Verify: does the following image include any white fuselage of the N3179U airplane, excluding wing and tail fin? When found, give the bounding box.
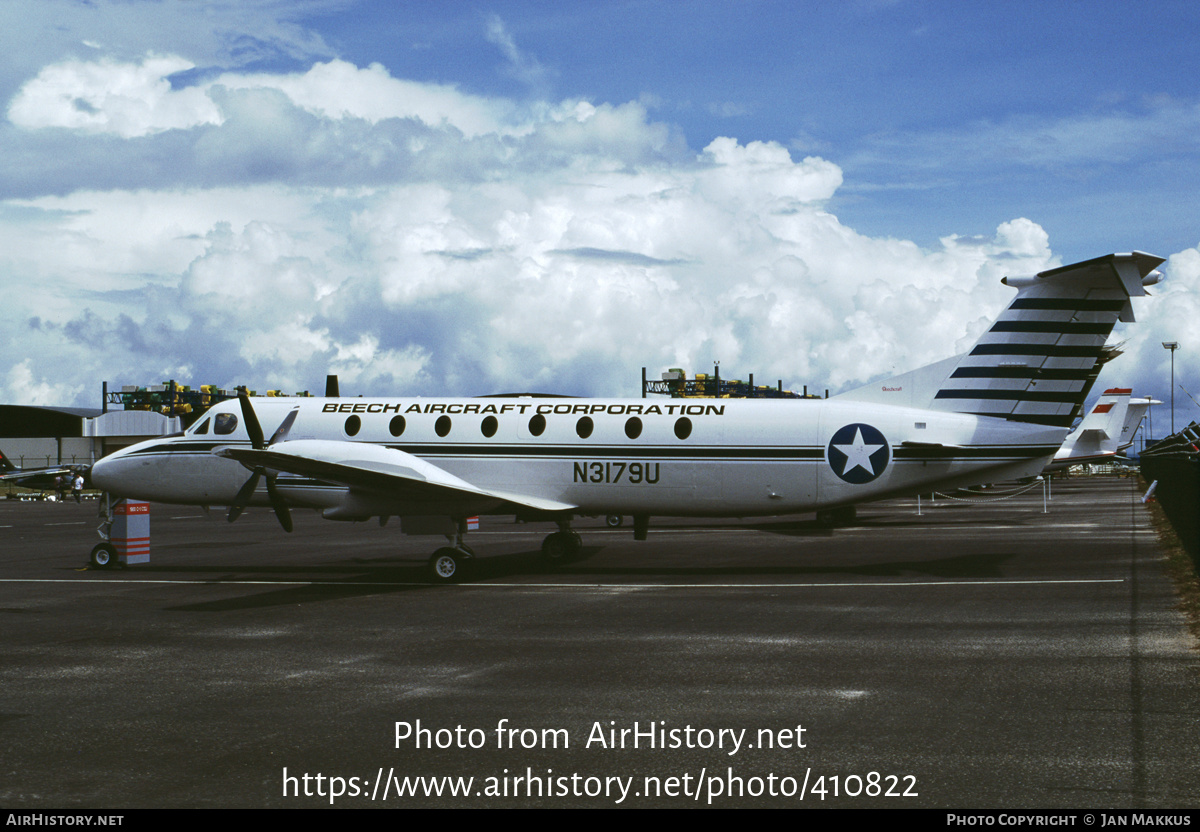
[92,397,1066,516]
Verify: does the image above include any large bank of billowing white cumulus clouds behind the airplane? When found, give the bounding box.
[0,51,1185,415]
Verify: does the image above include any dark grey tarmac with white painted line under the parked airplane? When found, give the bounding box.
[0,478,1200,810]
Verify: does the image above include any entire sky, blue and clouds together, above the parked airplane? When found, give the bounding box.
[0,0,1200,432]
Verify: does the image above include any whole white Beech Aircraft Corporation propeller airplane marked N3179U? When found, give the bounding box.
[91,252,1163,581]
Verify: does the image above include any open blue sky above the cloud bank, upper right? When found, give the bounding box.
[302,1,1200,261]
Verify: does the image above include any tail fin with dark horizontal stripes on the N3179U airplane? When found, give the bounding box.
[838,251,1163,427]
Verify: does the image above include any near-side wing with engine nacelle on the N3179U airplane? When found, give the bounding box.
[214,439,577,514]
